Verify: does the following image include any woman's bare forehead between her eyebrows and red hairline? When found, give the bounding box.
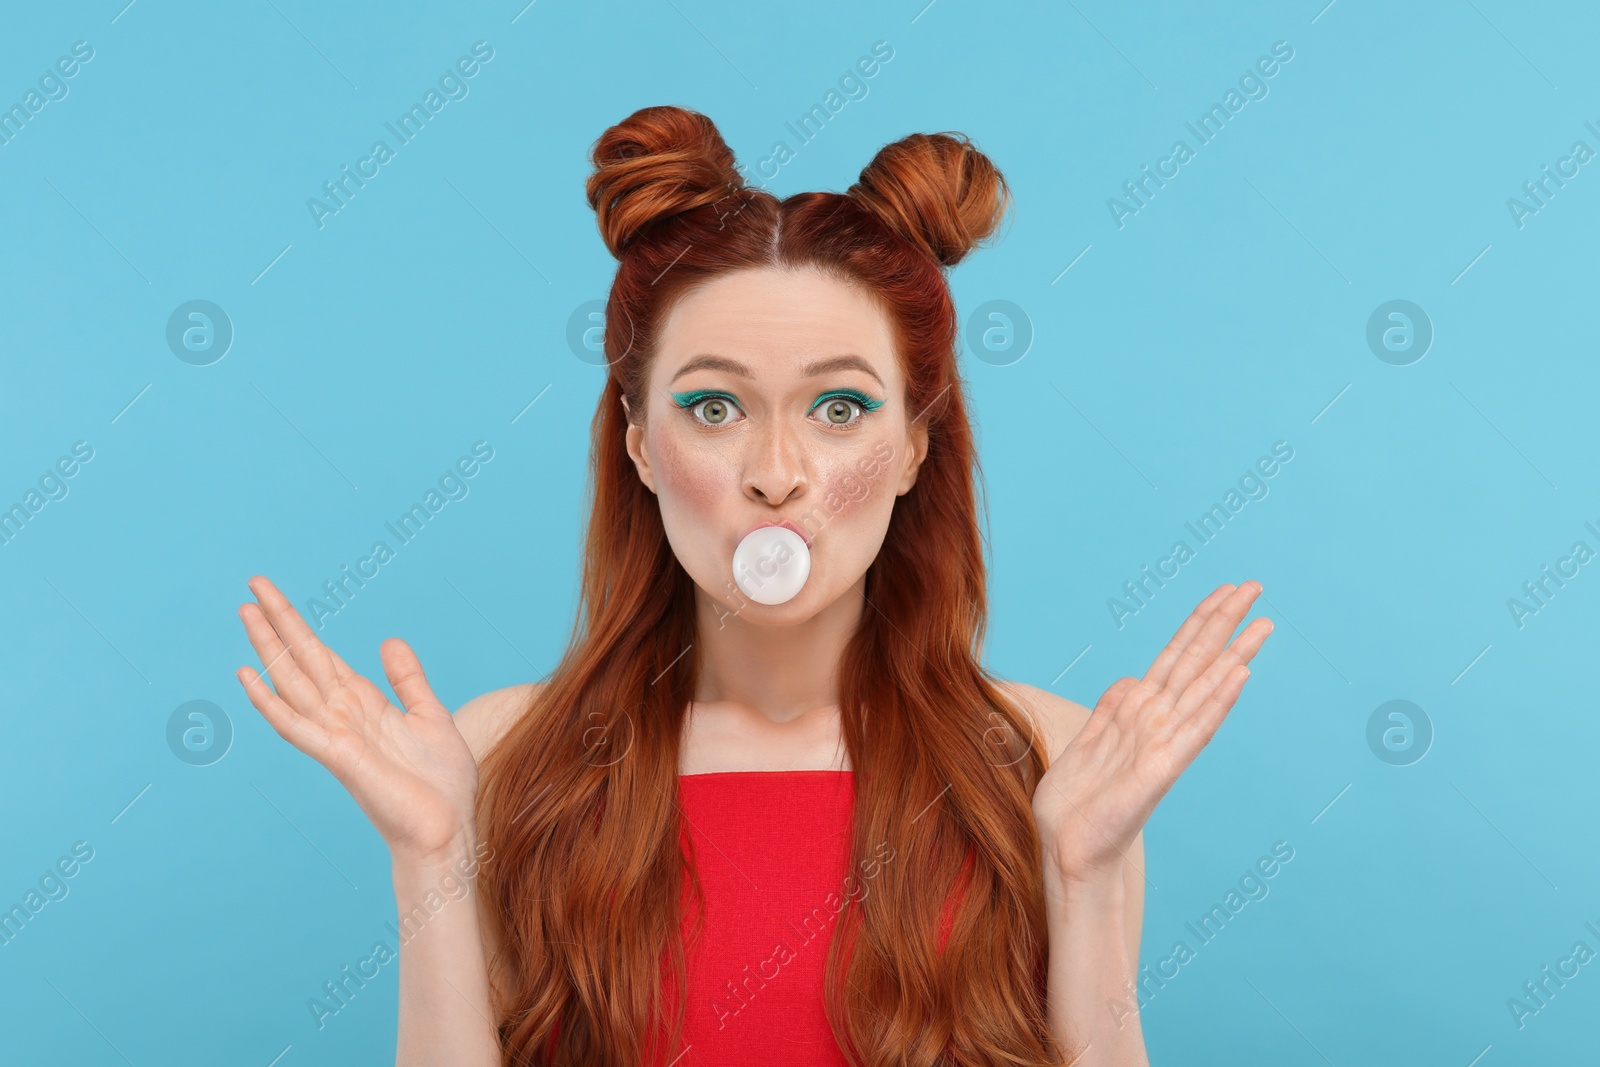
[656,267,898,381]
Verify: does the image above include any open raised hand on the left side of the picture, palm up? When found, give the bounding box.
[235,576,478,864]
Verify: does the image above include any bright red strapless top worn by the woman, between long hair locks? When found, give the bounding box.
[672,771,952,1067]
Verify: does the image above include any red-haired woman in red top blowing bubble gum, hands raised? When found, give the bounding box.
[238,107,1272,1067]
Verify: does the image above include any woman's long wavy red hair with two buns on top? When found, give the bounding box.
[478,107,1061,1067]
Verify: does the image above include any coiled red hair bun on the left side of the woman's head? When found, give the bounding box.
[584,106,744,259]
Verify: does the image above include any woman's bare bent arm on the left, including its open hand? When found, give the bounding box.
[238,576,528,1067]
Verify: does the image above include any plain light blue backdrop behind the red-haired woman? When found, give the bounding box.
[0,0,1600,1067]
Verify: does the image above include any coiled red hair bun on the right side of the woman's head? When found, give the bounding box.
[846,133,1011,267]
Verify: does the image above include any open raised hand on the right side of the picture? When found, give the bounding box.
[1034,581,1272,881]
